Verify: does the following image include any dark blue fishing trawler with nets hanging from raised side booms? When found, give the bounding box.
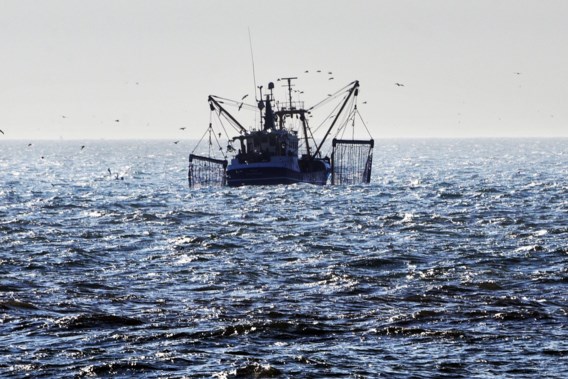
[188,77,374,188]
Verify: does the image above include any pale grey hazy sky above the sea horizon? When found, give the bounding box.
[0,0,568,139]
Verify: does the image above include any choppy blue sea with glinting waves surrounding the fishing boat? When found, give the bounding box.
[0,139,568,378]
